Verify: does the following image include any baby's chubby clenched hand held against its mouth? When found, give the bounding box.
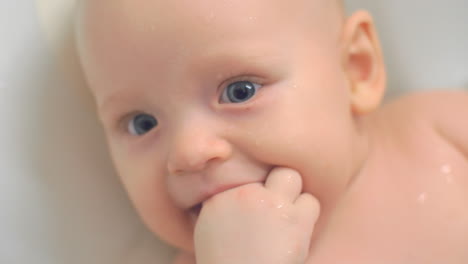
[195,168,319,264]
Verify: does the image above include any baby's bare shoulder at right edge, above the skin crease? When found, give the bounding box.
[381,90,468,159]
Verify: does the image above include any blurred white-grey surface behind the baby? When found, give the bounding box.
[0,0,468,264]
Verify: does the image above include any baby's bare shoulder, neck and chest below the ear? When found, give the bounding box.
[175,91,468,264]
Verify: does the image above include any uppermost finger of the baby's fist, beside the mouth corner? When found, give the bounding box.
[265,167,302,202]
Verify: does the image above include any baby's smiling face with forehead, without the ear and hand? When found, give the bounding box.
[78,0,366,250]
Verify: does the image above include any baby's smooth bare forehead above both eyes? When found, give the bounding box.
[77,0,340,100]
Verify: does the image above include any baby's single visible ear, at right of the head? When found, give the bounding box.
[342,11,386,115]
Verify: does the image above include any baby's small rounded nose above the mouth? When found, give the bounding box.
[167,124,232,175]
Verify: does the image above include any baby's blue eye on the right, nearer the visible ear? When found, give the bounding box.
[220,81,260,103]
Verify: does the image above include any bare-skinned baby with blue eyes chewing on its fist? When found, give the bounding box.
[73,0,468,264]
